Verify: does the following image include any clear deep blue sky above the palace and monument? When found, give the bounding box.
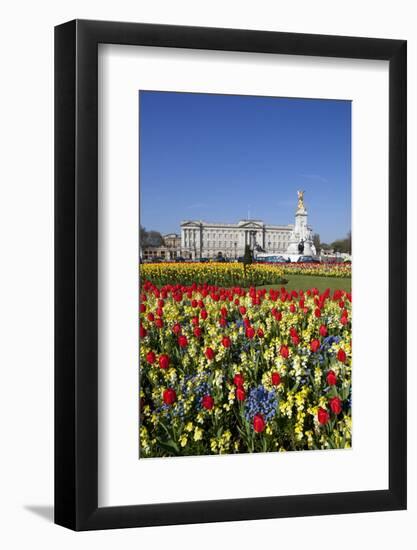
[139,91,351,242]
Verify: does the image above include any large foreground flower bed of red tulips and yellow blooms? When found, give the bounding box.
[140,280,351,457]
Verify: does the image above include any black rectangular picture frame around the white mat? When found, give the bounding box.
[55,20,407,531]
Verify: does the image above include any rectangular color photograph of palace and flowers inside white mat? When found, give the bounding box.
[139,91,352,458]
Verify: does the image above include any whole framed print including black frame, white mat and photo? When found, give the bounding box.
[55,21,406,530]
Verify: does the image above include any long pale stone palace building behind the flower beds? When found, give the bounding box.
[181,220,294,258]
